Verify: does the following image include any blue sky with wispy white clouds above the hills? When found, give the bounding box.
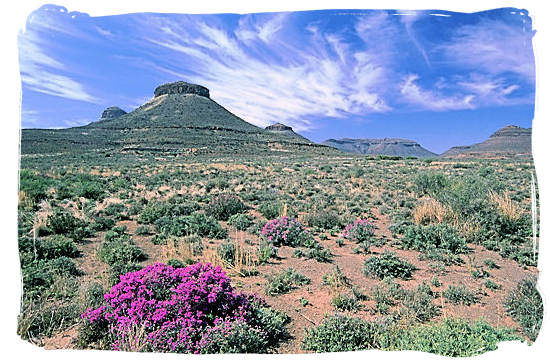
[19,5,535,153]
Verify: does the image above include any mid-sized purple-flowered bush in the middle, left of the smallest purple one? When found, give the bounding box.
[262,216,317,247]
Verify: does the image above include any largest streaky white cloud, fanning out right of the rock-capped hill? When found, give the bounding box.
[142,15,390,131]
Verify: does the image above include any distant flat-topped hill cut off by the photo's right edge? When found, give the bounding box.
[441,125,531,157]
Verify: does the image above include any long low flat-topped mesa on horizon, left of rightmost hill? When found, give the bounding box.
[321,138,437,158]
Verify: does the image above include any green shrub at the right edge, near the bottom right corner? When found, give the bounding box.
[504,276,544,341]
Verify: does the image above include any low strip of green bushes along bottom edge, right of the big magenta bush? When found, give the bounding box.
[302,315,518,357]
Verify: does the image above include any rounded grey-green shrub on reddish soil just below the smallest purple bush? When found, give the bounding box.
[363,252,416,279]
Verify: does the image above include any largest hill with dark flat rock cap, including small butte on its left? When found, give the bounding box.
[21,81,339,155]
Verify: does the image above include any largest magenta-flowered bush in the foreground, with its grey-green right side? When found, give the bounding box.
[81,263,288,353]
